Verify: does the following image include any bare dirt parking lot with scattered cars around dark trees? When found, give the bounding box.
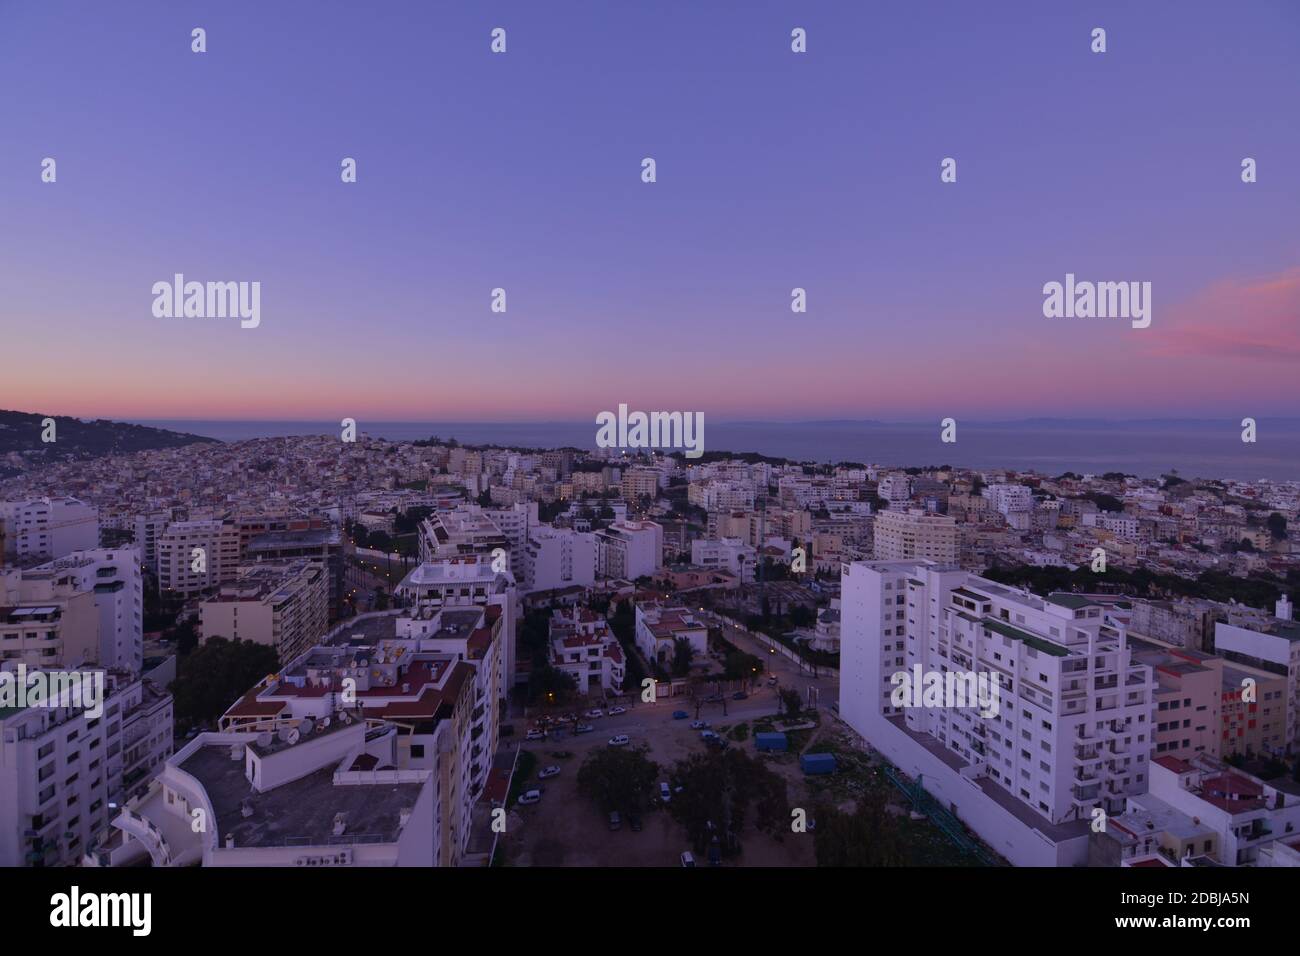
[502,688,815,866]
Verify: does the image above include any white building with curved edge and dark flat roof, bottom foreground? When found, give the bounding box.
[83,714,446,868]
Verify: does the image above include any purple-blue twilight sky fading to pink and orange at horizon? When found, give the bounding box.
[0,0,1300,420]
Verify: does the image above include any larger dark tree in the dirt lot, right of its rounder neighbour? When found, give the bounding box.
[668,748,790,856]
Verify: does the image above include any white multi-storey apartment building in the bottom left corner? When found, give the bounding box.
[0,671,173,866]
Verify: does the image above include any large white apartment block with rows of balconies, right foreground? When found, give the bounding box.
[840,562,1156,866]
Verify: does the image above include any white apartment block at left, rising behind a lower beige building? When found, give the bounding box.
[27,546,144,674]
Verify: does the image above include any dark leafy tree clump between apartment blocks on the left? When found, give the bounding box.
[172,637,280,727]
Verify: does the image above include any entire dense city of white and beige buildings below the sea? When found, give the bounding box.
[0,423,1300,868]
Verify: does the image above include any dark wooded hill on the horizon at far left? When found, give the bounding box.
[0,410,217,467]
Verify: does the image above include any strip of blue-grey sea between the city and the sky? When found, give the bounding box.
[131,418,1300,481]
